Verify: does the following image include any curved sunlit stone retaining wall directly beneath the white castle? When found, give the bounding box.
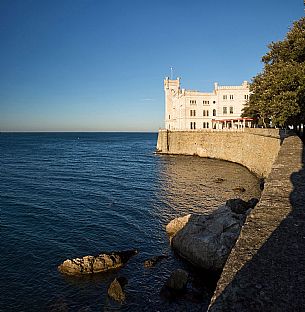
[157,129,281,177]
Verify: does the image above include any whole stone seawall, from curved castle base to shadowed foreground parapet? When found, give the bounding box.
[157,129,305,312]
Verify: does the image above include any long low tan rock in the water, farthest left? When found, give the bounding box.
[58,249,138,275]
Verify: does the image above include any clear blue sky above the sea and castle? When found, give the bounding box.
[0,0,304,131]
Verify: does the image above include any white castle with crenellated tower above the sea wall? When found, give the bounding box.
[164,77,252,130]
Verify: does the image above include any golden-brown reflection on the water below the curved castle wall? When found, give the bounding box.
[156,155,260,221]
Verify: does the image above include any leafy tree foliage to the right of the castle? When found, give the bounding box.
[243,17,305,126]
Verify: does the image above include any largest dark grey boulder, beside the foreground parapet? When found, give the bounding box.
[166,199,253,271]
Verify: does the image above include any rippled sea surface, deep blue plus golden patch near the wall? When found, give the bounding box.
[0,133,259,311]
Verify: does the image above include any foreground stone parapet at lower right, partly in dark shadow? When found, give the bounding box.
[209,137,305,312]
